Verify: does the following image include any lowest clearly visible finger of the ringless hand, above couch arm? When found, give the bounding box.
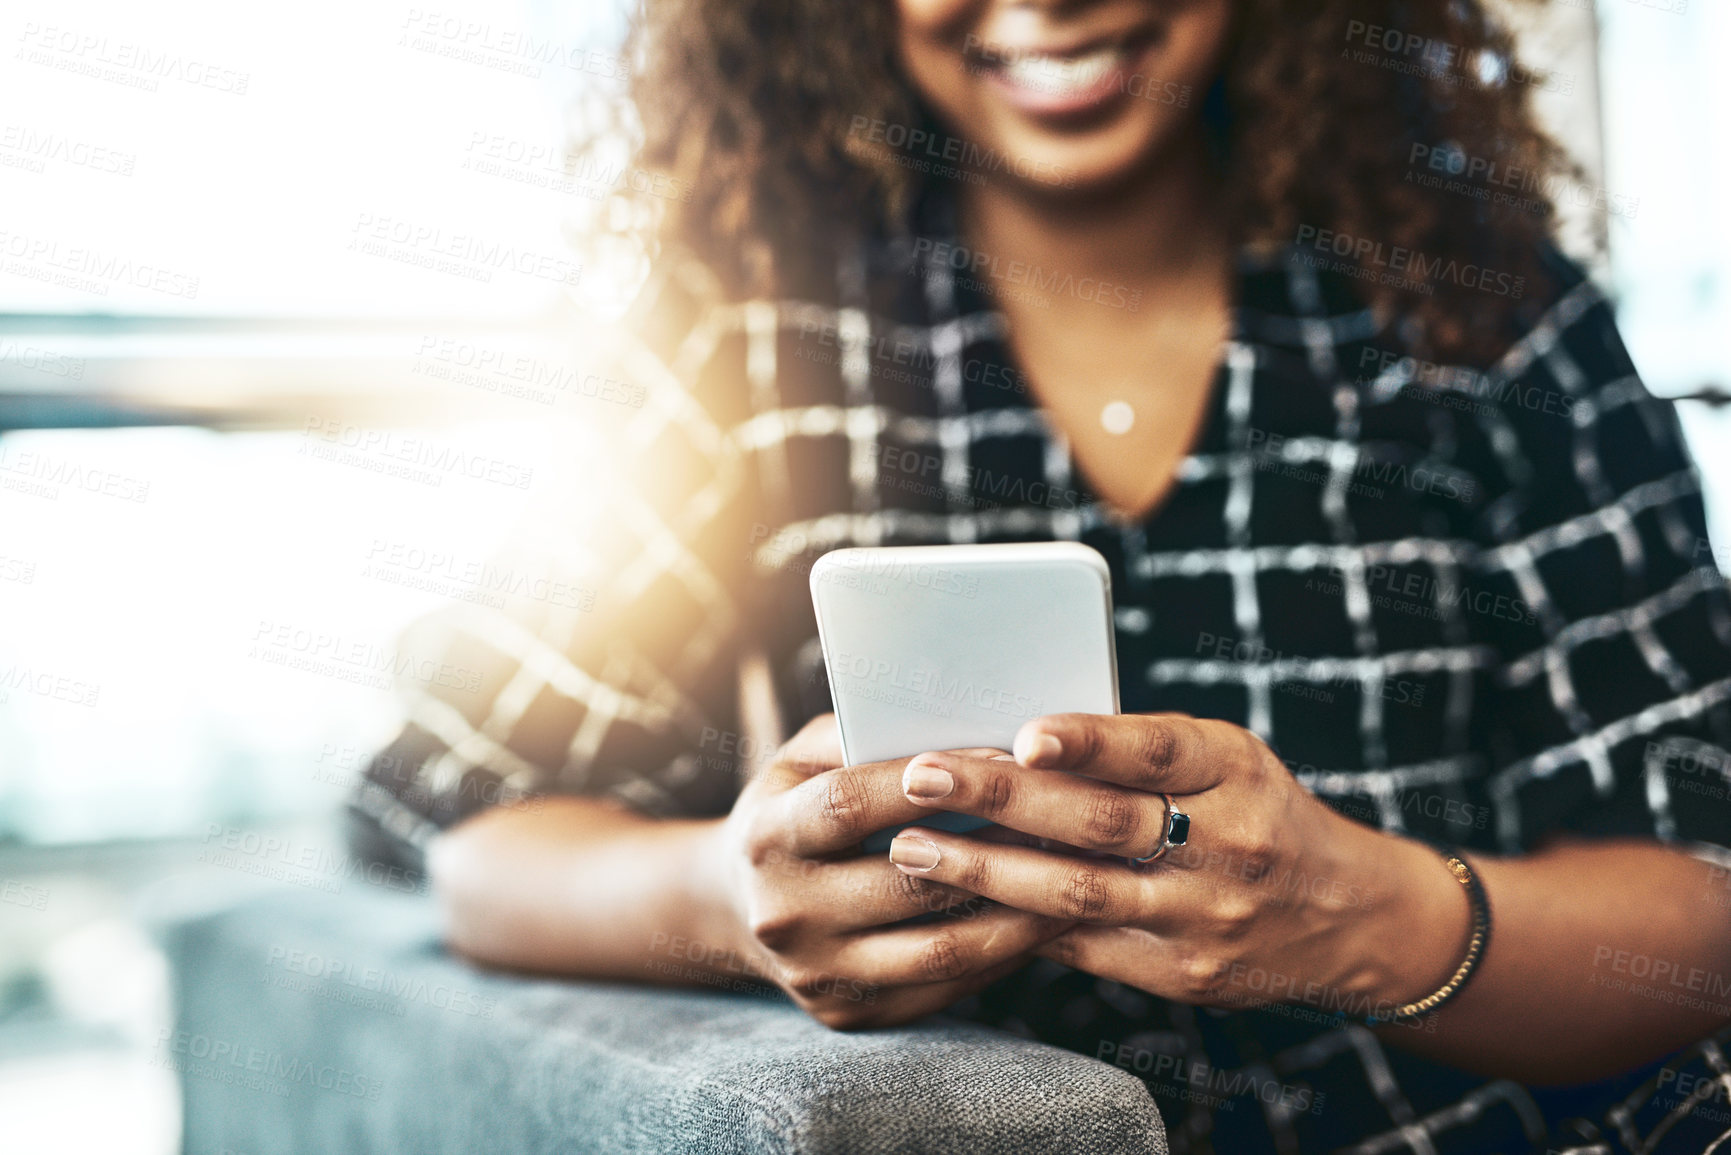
[833,906,1070,987]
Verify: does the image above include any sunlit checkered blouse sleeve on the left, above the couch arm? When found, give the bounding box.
[350,263,750,868]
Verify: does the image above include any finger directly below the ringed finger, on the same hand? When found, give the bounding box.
[890,826,1203,926]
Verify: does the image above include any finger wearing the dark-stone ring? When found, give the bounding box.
[902,753,1167,857]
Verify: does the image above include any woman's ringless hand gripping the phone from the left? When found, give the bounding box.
[703,713,1071,1030]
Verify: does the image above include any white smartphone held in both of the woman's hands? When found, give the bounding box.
[810,542,1118,849]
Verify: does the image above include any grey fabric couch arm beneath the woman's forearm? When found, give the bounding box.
[158,887,1167,1155]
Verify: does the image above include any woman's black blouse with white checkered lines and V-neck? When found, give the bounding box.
[353,193,1731,1155]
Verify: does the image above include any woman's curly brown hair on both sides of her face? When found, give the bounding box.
[615,0,1577,364]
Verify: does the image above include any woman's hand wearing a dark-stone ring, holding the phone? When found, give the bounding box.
[890,713,1470,1015]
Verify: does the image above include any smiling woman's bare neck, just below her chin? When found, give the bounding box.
[959,132,1226,293]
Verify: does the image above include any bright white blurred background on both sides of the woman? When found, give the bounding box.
[0,0,1731,1155]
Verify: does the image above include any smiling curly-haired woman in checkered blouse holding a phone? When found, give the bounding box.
[347,0,1731,1152]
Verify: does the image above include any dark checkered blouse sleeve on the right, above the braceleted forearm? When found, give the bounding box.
[1471,259,1731,864]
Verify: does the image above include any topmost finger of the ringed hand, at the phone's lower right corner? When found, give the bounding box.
[1016,713,1267,795]
